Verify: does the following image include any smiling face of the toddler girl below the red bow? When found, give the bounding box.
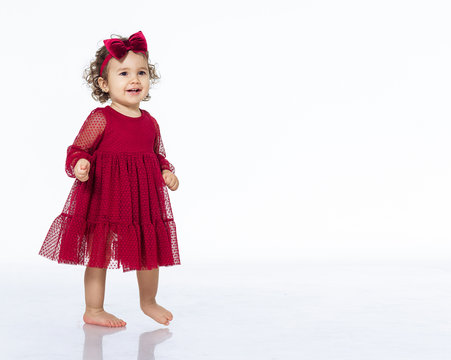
[98,51,150,109]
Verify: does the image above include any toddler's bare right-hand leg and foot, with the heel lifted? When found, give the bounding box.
[136,268,173,325]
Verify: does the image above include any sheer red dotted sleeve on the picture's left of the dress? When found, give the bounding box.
[66,108,106,178]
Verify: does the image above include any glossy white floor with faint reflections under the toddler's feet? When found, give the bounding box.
[0,258,451,360]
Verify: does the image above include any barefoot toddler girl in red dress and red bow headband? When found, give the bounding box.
[39,31,180,327]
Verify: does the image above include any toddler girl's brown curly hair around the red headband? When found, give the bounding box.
[83,34,160,103]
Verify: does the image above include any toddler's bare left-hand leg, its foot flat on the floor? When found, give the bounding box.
[83,266,126,327]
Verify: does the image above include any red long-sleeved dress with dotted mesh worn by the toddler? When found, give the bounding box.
[39,106,180,272]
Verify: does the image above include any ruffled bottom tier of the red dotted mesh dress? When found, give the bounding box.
[39,212,180,272]
